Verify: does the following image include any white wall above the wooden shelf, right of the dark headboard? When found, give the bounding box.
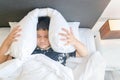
[92,0,120,34]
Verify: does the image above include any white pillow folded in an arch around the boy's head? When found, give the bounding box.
[8,8,79,58]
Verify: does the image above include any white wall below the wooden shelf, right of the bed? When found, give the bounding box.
[95,32,120,67]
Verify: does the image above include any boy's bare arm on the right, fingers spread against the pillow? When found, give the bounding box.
[60,28,88,57]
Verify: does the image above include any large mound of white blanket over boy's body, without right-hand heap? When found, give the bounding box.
[0,54,74,80]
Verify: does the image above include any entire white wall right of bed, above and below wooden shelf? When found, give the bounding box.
[92,0,120,67]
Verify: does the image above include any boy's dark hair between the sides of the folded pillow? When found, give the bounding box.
[37,16,50,30]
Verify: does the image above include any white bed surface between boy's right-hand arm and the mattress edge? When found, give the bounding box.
[79,28,96,54]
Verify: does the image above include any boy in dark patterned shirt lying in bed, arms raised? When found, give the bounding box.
[0,17,88,65]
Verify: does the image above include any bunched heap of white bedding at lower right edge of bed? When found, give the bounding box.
[67,52,105,80]
